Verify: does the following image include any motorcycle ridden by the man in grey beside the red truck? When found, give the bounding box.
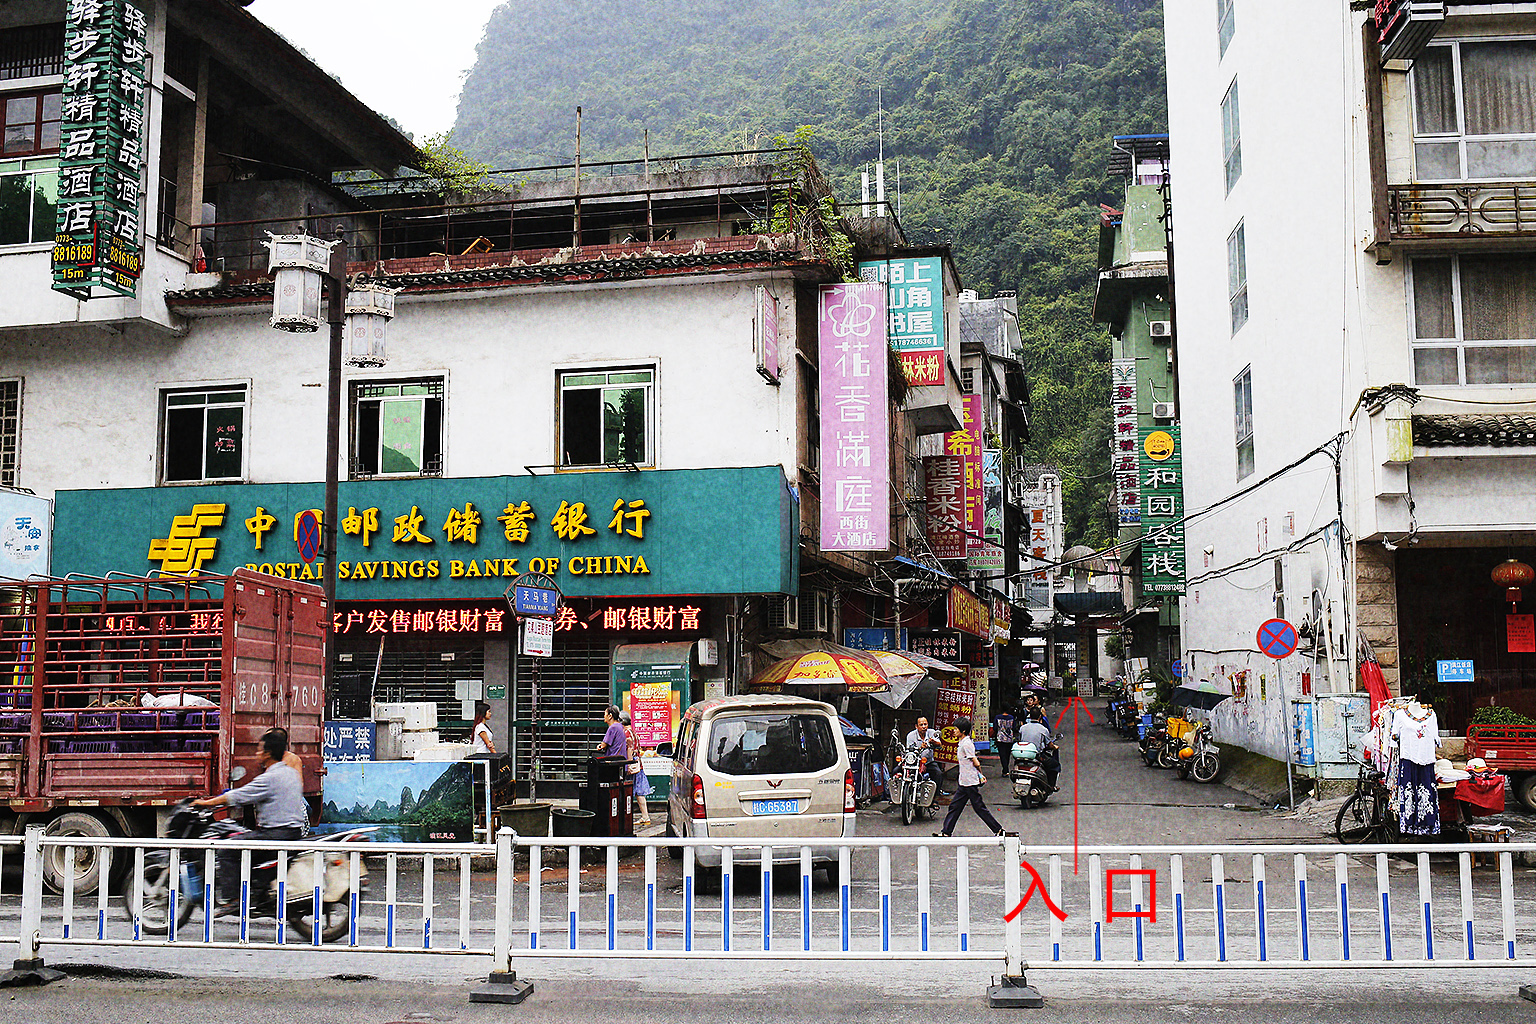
[123,801,378,943]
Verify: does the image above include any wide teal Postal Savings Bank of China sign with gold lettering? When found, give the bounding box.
[54,467,804,600]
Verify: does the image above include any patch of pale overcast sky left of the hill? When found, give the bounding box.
[249,0,502,143]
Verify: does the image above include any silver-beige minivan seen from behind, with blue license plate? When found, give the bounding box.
[667,694,854,867]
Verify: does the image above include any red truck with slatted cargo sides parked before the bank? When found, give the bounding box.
[0,570,329,892]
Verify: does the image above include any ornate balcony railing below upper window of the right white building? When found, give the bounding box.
[1387,181,1536,244]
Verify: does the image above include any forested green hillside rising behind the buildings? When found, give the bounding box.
[453,0,1161,545]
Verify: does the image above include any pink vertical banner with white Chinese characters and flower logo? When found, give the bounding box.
[817,281,891,551]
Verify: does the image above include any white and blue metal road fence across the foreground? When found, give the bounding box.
[0,829,1536,973]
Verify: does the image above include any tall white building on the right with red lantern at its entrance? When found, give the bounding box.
[1164,0,1536,757]
